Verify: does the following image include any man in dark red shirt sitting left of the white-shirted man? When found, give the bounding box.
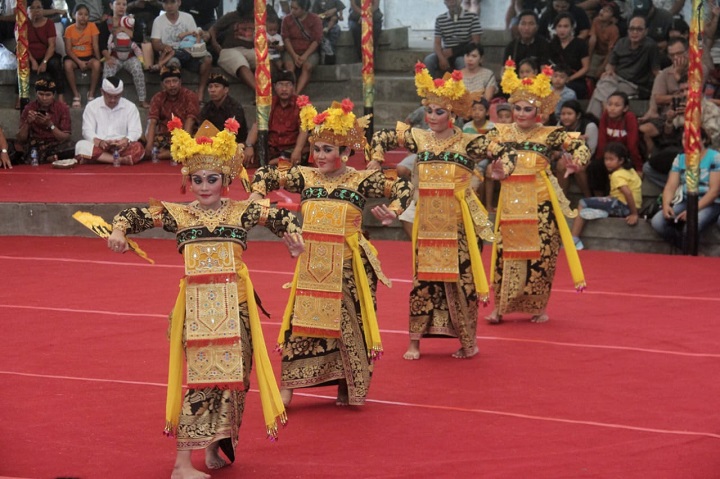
[15,75,72,164]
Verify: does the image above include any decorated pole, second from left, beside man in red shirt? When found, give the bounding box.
[255,0,272,166]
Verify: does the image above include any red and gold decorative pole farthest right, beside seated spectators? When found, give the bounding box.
[683,0,704,256]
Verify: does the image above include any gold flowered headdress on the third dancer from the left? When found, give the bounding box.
[415,62,472,118]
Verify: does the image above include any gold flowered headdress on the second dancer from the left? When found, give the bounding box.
[297,95,370,156]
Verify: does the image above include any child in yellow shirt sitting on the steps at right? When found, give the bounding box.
[572,142,642,250]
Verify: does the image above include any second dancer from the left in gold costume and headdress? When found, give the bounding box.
[251,96,412,406]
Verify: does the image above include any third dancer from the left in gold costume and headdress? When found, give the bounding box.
[368,63,514,360]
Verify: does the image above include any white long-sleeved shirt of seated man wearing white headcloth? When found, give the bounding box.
[82,95,142,141]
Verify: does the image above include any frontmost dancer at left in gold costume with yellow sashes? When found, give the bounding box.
[108,118,303,479]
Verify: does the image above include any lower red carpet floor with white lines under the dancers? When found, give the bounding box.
[0,238,720,479]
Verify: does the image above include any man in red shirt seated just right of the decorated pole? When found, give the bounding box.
[245,69,309,167]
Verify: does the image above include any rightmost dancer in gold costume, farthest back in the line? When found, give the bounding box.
[485,60,590,323]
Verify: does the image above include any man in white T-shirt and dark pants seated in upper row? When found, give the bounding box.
[150,0,212,101]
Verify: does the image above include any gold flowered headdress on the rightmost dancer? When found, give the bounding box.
[500,58,560,115]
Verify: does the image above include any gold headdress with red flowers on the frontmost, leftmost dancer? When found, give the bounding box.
[167,115,247,191]
